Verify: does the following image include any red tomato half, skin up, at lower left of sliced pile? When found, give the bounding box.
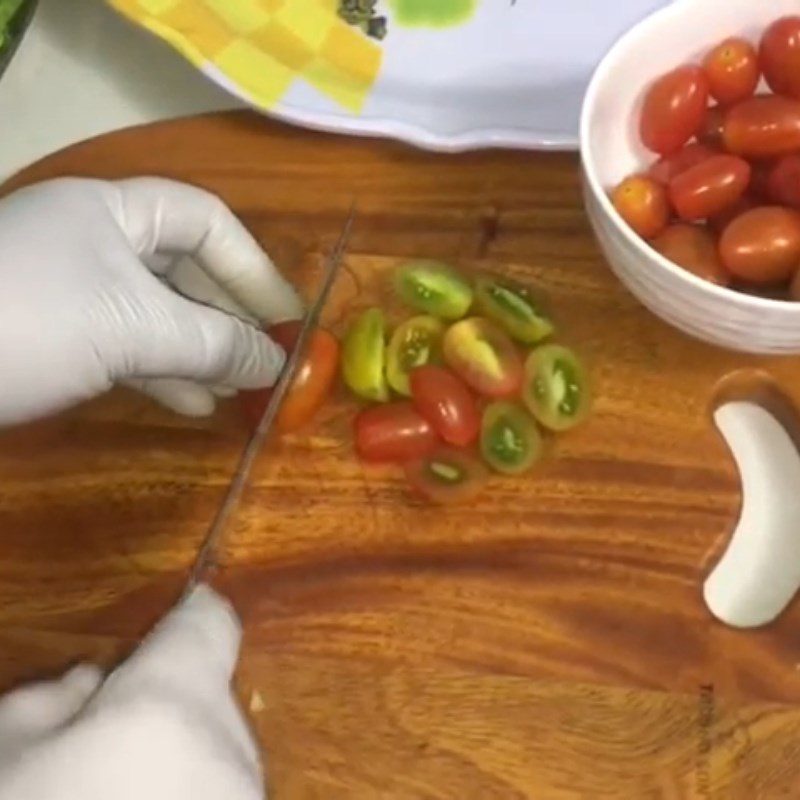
[353,400,437,463]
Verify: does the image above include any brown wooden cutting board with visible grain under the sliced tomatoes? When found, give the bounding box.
[0,114,800,800]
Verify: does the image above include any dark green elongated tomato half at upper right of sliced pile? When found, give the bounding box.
[475,275,553,344]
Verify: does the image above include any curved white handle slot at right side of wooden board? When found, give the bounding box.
[703,402,800,628]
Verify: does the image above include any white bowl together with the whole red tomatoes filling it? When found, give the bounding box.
[581,0,800,354]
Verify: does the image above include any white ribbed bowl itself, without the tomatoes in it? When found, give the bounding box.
[580,0,800,353]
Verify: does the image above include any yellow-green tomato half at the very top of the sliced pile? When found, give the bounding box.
[395,260,472,320]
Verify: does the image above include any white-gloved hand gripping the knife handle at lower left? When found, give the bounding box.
[0,587,264,800]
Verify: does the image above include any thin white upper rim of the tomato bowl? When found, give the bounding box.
[579,0,800,316]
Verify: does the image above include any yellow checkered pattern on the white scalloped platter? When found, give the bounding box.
[109,0,383,113]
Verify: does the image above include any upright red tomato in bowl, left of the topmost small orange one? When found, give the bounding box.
[639,65,709,155]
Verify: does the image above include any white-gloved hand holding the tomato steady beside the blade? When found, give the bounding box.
[0,178,302,425]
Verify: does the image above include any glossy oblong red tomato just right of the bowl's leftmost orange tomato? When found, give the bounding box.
[669,155,750,222]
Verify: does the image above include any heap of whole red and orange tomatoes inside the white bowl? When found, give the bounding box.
[611,16,800,300]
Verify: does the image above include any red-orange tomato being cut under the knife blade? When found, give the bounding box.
[239,321,339,433]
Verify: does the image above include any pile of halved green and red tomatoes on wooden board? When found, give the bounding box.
[342,261,590,503]
